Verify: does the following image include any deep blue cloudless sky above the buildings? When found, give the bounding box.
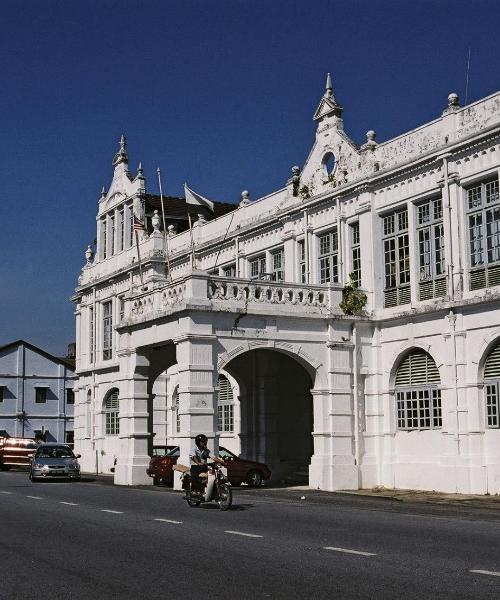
[0,0,500,354]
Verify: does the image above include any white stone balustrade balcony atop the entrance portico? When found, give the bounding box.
[118,271,348,328]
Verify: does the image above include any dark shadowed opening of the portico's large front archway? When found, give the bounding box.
[224,348,314,483]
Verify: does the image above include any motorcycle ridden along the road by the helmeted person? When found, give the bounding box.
[172,463,233,510]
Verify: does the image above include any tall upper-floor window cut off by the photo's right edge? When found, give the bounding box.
[466,177,500,290]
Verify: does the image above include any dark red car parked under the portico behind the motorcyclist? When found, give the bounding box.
[146,446,271,487]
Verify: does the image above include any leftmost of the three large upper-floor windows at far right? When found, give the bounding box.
[382,209,411,308]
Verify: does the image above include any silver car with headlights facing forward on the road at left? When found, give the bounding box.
[29,444,80,481]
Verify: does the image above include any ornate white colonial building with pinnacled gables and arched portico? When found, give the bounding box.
[74,77,500,493]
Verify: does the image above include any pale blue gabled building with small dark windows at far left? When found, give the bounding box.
[0,340,76,444]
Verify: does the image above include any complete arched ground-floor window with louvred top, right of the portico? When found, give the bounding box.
[396,350,443,430]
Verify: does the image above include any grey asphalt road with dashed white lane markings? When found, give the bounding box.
[0,471,500,600]
